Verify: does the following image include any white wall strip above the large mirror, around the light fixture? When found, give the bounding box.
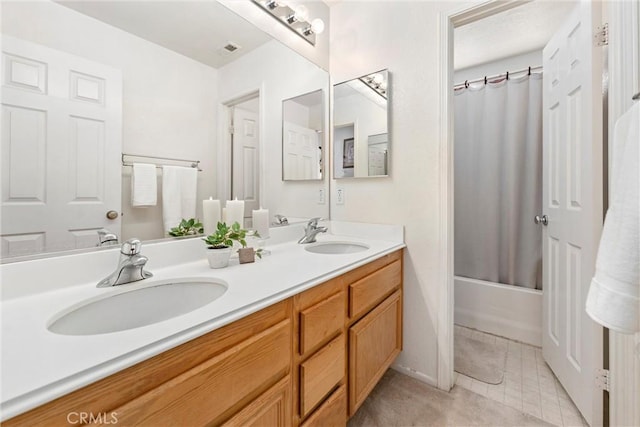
[218,0,331,70]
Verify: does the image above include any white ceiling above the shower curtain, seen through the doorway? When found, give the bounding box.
[454,0,577,70]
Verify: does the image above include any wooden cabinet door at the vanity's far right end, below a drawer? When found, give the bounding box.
[349,291,402,417]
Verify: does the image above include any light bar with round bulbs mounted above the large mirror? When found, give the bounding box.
[252,0,324,46]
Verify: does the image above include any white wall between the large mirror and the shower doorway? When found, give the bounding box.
[331,1,479,387]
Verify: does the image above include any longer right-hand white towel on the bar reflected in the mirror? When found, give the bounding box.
[162,166,198,233]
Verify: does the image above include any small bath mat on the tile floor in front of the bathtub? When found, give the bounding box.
[454,333,507,384]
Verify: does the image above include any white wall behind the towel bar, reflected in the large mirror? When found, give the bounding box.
[2,1,217,240]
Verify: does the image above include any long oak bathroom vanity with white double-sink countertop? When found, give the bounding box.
[2,222,404,426]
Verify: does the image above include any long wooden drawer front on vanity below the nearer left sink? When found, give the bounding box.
[114,320,291,426]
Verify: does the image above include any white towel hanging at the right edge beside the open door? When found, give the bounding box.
[586,103,640,333]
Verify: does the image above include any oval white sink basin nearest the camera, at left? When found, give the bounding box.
[48,279,227,335]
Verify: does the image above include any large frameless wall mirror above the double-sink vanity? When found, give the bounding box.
[0,0,329,262]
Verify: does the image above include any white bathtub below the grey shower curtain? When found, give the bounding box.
[454,276,542,347]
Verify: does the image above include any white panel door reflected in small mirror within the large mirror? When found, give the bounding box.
[283,122,320,180]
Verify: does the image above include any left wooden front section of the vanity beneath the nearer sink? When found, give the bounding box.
[2,299,292,427]
